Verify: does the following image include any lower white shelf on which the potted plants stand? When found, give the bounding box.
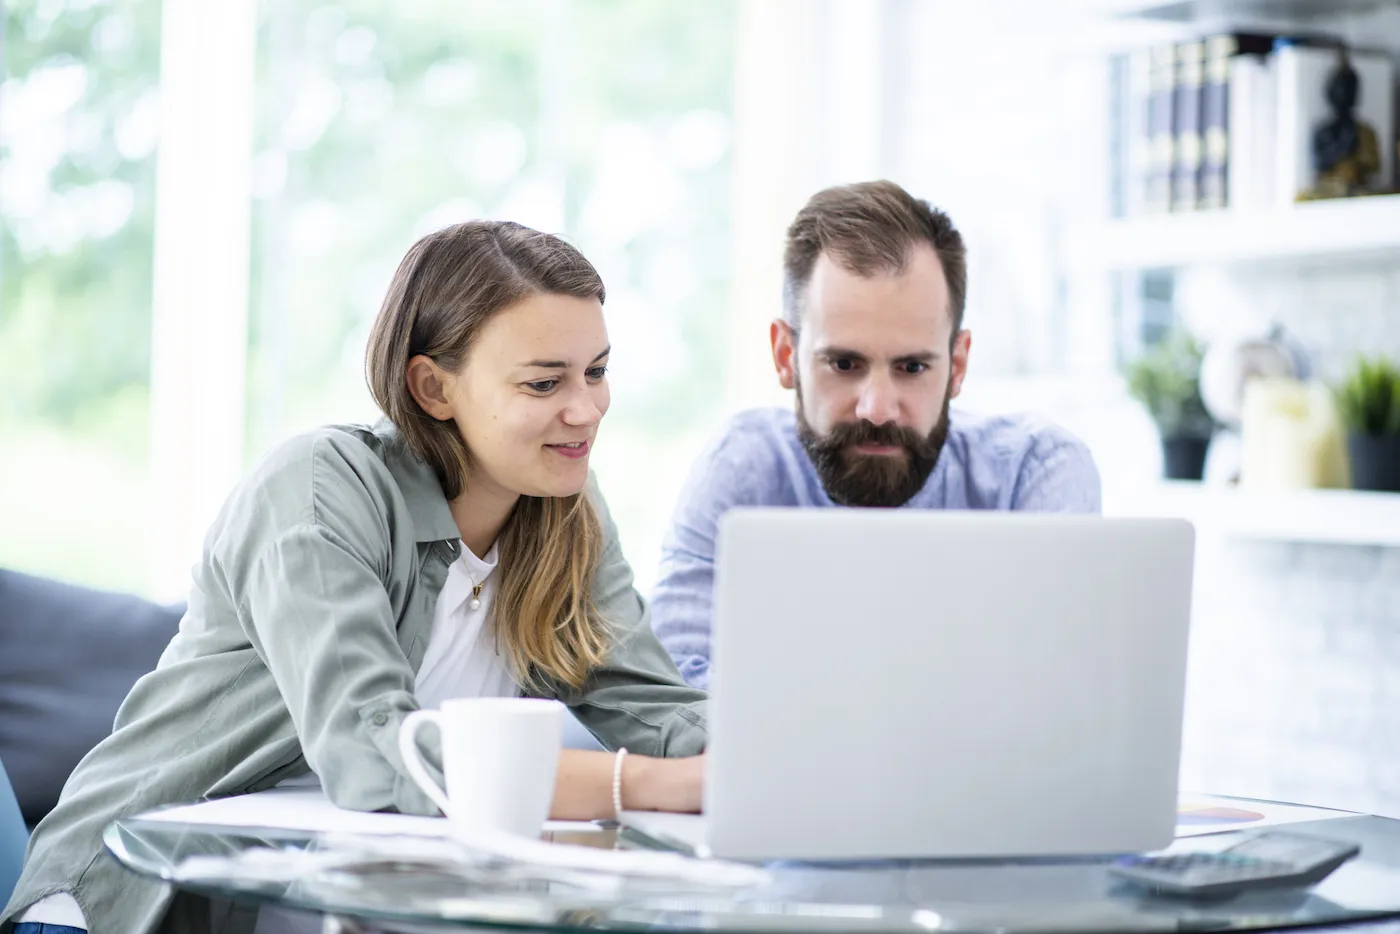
[1105,482,1400,546]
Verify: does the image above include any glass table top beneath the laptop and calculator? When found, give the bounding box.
[105,816,1400,934]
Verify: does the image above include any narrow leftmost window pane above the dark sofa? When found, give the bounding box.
[0,0,161,590]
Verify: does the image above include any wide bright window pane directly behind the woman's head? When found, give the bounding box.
[246,0,735,585]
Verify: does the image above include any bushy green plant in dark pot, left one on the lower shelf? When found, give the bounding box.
[1127,330,1215,480]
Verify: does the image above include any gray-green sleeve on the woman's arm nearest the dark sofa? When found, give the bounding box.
[216,440,441,814]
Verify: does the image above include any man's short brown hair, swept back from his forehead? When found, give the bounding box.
[783,181,967,335]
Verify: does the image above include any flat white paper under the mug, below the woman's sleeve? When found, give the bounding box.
[139,787,585,836]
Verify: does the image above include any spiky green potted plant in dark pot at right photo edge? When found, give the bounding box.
[1336,357,1400,493]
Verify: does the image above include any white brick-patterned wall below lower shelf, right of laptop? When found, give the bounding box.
[1183,541,1400,814]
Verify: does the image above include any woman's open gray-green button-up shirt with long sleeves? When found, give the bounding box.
[0,423,706,934]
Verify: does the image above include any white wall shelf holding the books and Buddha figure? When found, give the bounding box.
[1071,195,1400,270]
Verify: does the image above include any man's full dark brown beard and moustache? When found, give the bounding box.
[797,381,952,507]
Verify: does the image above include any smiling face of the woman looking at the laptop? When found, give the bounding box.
[422,294,609,496]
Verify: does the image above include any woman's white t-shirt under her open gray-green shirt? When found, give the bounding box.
[17,545,519,934]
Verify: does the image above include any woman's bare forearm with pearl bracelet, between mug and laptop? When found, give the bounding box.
[549,749,704,821]
